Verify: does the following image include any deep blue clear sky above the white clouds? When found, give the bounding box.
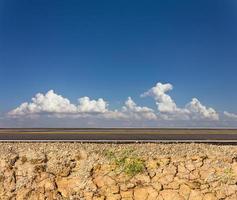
[0,0,237,126]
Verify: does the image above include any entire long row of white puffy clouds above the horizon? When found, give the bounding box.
[4,83,237,125]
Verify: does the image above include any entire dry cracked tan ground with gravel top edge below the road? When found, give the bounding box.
[0,143,237,200]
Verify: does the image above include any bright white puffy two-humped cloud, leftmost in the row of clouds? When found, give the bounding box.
[8,90,107,117]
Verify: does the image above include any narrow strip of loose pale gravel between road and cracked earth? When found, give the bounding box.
[0,142,237,157]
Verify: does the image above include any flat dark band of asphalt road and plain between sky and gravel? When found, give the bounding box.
[0,128,237,142]
